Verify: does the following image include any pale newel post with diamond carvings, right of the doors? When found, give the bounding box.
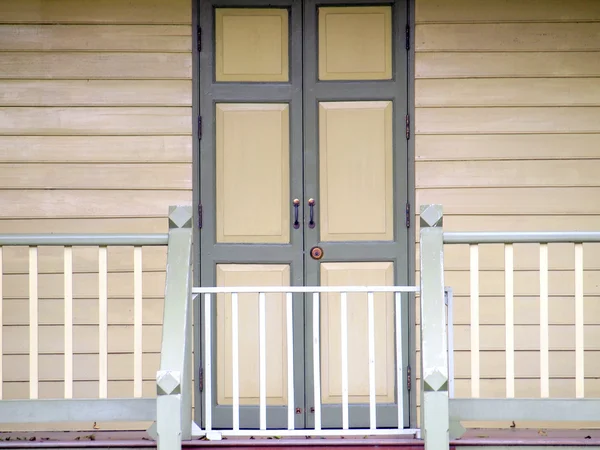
[420,205,450,450]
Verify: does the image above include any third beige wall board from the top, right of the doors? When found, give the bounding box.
[415,52,600,78]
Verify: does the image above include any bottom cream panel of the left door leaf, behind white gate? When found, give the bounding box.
[217,264,290,405]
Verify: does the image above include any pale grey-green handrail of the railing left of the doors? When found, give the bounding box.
[0,233,169,247]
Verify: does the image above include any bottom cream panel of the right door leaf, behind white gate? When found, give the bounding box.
[321,262,395,404]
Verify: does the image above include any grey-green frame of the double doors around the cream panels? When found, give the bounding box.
[191,0,416,429]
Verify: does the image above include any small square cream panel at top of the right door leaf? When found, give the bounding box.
[319,6,392,80]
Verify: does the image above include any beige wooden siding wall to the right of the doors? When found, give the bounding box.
[415,0,600,426]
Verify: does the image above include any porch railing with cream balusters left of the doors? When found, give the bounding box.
[0,234,168,424]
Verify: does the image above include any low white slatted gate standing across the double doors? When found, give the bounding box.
[192,286,419,439]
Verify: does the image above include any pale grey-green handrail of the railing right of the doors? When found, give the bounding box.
[444,231,600,244]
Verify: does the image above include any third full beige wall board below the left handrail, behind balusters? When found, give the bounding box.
[2,297,164,327]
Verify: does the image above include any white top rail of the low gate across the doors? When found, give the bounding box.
[192,286,419,294]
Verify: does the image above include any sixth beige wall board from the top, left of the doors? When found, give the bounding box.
[0,136,192,164]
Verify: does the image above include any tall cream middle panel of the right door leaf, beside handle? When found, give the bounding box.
[319,101,394,241]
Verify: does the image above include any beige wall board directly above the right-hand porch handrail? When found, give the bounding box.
[414,215,600,236]
